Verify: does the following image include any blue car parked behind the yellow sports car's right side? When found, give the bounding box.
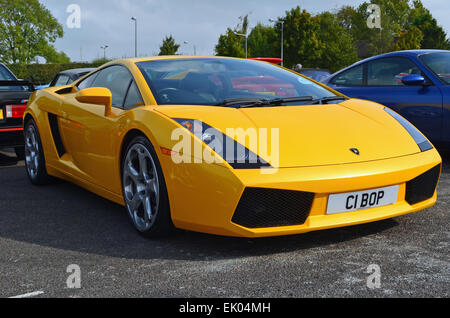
[323,50,450,148]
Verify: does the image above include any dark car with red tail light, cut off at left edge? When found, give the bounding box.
[0,63,34,159]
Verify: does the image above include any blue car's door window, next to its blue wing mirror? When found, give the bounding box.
[367,57,424,86]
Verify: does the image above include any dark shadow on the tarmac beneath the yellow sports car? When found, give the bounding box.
[0,167,404,261]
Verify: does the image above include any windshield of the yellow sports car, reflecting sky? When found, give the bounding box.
[137,58,336,105]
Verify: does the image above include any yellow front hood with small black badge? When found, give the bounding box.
[157,99,420,168]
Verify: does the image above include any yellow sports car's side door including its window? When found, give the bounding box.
[62,65,137,192]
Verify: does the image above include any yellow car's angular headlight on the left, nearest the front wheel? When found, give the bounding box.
[173,118,272,169]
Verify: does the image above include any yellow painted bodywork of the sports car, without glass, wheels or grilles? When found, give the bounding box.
[24,57,441,237]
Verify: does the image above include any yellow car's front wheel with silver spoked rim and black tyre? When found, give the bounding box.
[122,136,174,238]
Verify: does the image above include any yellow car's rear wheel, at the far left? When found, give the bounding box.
[24,119,52,185]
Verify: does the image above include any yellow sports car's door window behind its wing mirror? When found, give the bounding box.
[91,65,133,108]
